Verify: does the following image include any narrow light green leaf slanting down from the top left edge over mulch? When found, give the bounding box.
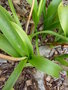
[8,0,21,27]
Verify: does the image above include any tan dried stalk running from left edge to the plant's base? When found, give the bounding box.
[0,54,27,61]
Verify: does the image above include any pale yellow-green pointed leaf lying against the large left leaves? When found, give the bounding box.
[11,22,33,56]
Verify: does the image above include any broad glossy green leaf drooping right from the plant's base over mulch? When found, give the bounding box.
[29,56,62,77]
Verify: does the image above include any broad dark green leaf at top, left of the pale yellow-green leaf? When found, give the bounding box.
[43,0,62,30]
